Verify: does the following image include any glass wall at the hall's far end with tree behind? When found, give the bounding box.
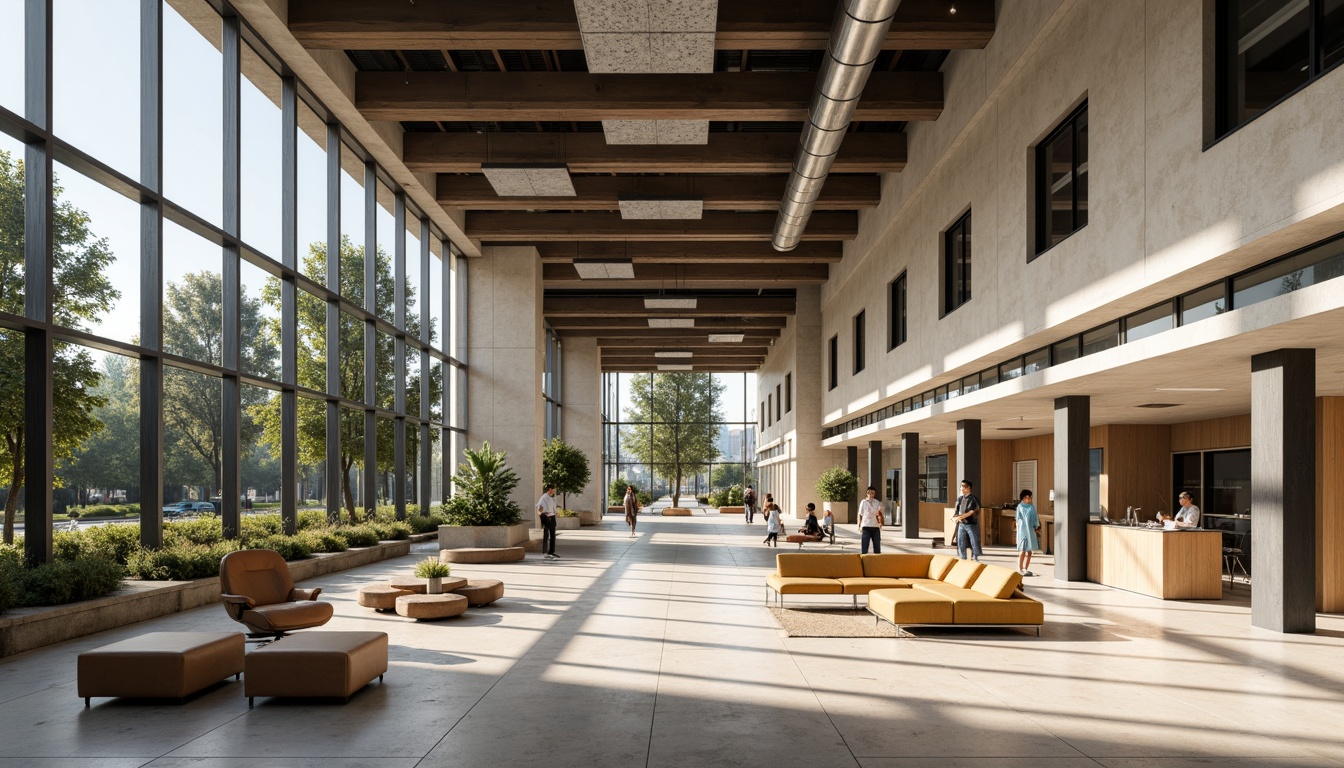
[602,373,757,504]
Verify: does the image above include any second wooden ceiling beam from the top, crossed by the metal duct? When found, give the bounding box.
[355,71,943,121]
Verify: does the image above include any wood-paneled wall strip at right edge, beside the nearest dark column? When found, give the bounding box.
[1316,397,1344,613]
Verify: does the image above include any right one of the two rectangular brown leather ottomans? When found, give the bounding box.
[243,632,387,709]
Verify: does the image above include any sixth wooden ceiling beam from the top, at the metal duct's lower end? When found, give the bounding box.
[532,241,844,264]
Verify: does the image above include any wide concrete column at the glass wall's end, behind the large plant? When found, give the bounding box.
[466,246,546,525]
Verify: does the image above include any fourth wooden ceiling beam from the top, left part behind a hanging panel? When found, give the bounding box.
[437,174,882,211]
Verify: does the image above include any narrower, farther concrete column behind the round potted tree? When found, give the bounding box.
[560,336,606,512]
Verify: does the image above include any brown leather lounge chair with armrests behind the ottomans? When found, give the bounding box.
[219,549,335,638]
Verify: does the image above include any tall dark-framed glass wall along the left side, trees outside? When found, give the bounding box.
[0,0,466,560]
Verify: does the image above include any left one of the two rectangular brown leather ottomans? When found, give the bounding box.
[78,632,243,706]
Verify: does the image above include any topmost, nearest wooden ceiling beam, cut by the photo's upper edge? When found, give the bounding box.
[289,0,995,51]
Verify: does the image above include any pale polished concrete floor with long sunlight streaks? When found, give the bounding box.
[0,515,1344,768]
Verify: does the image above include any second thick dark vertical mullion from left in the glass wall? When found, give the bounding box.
[140,0,164,547]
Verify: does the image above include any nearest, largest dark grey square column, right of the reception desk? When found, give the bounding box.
[1251,350,1316,633]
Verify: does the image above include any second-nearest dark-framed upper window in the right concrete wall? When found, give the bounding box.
[1036,101,1087,256]
